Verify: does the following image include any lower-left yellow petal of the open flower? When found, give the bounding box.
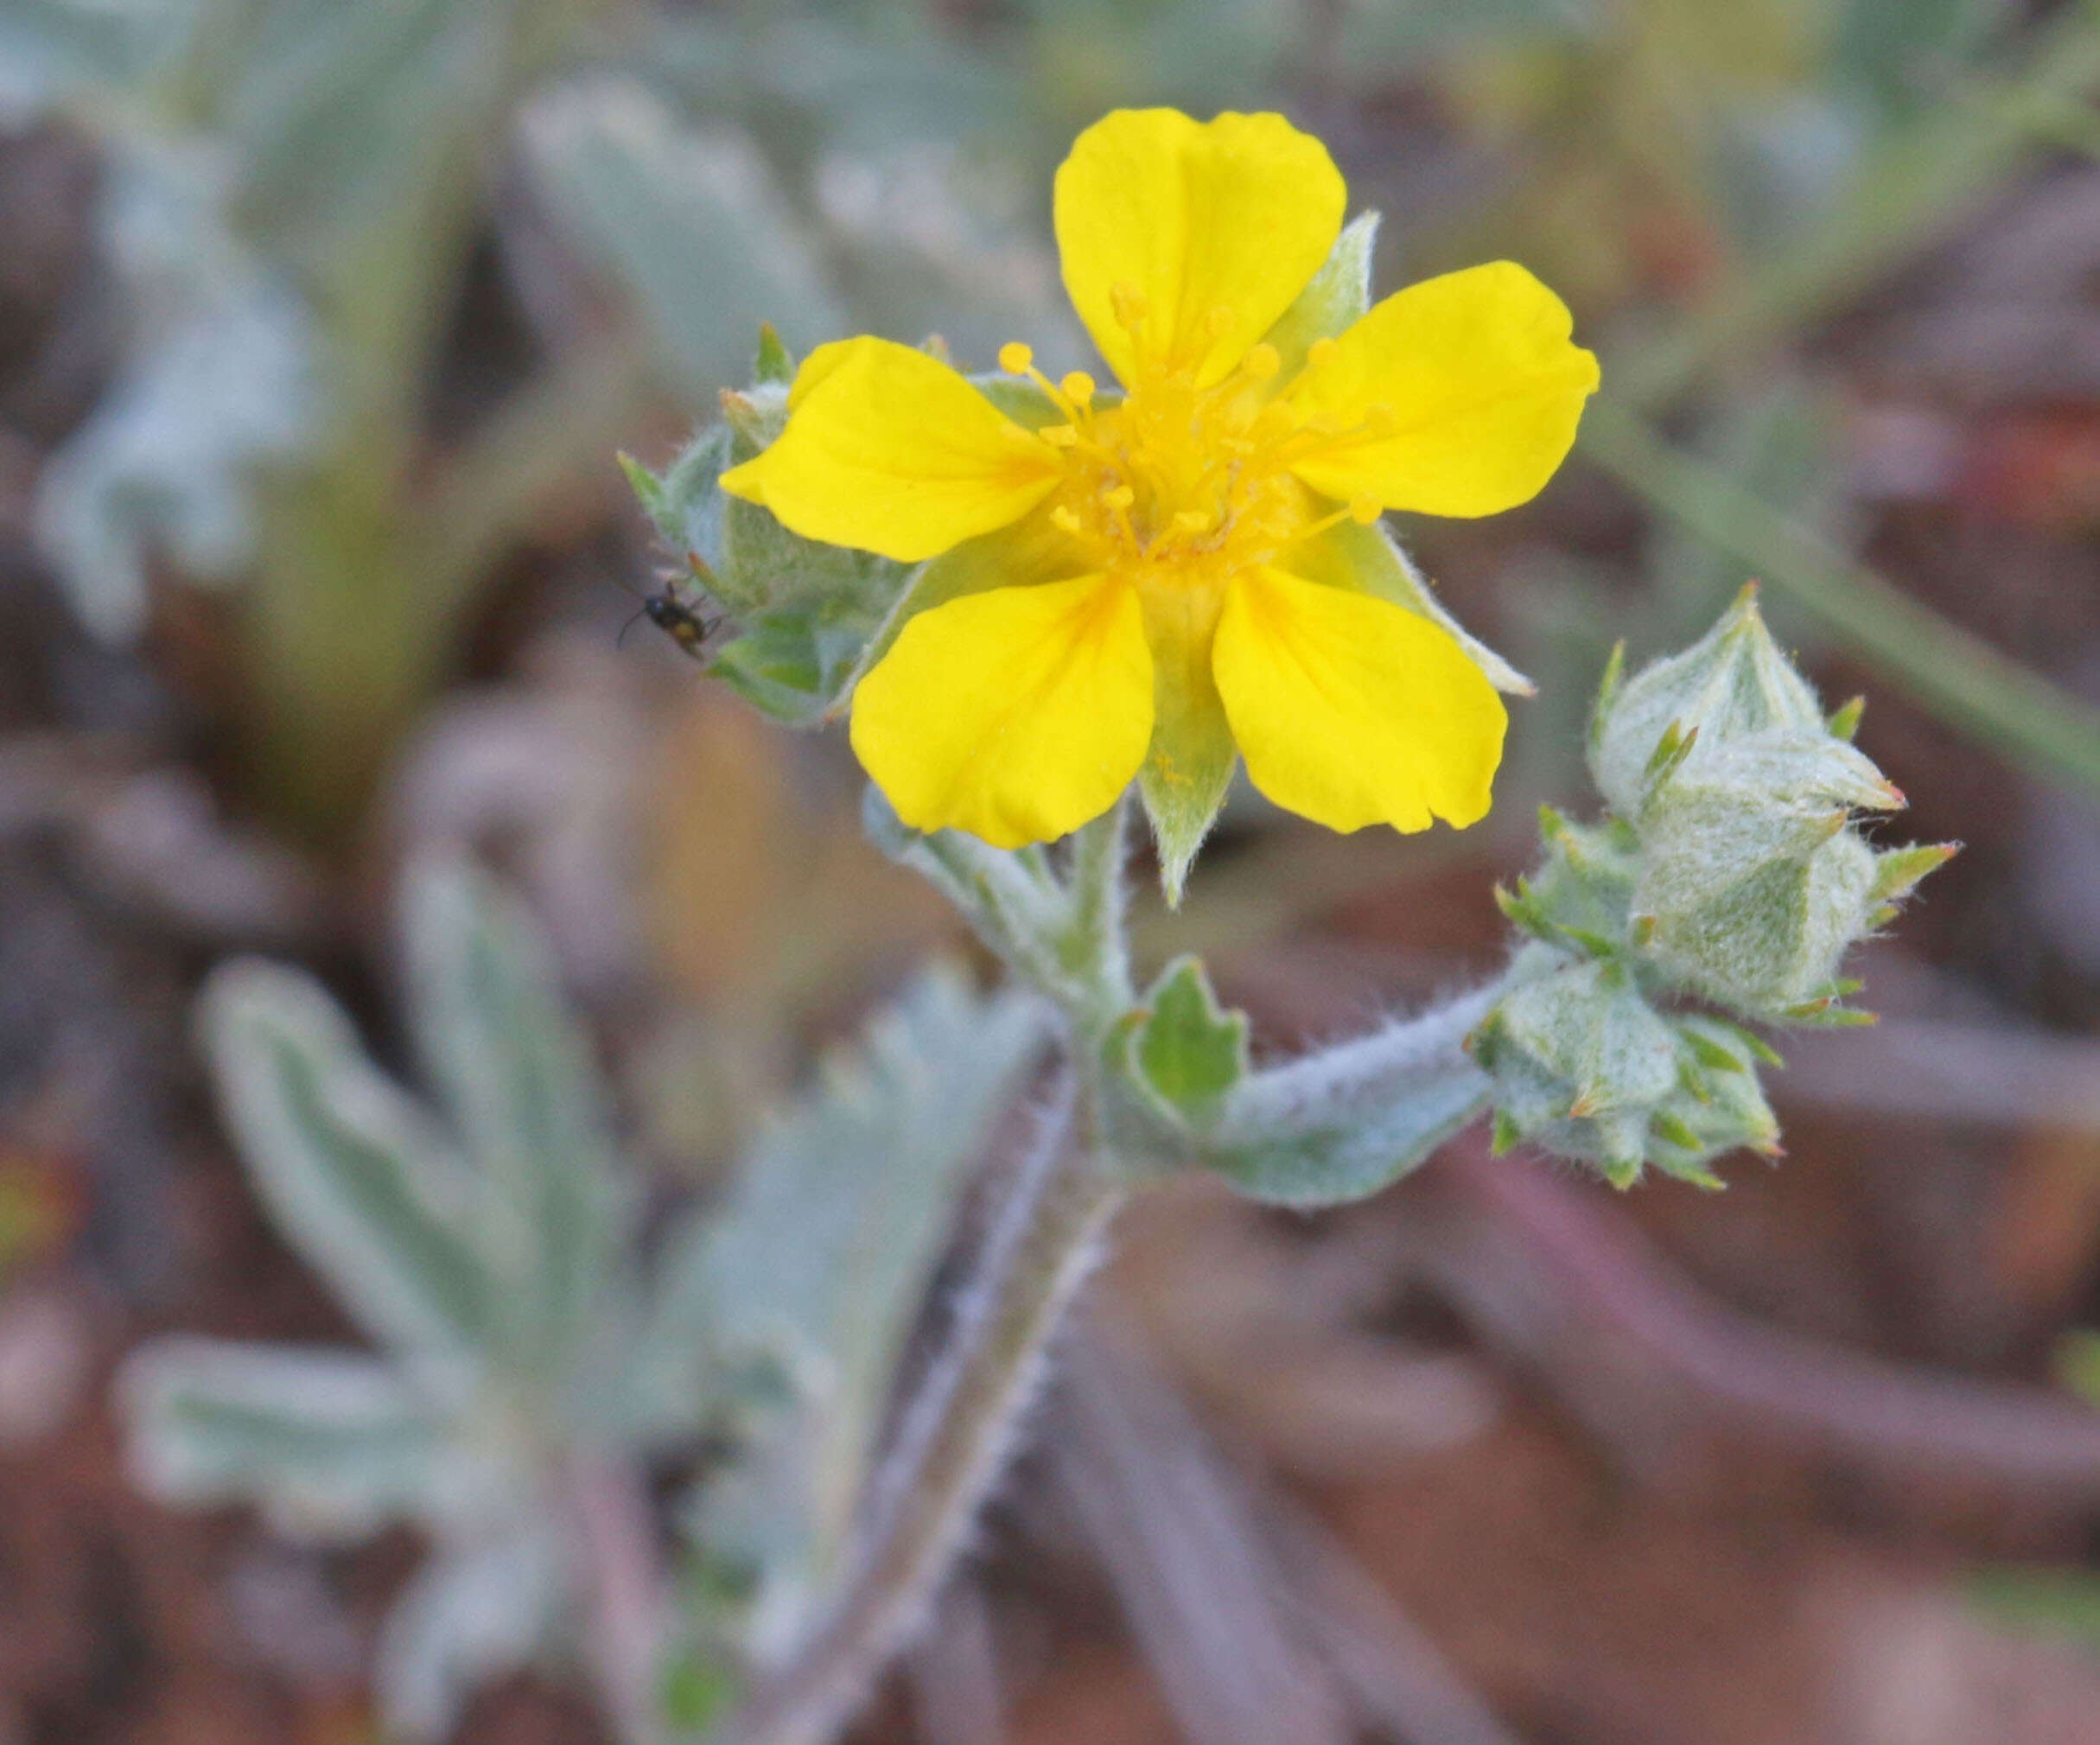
[853,576,1153,849]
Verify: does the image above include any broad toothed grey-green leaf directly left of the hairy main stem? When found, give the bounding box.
[651,968,1048,1604]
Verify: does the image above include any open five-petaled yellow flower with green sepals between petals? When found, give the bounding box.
[722,109,1596,873]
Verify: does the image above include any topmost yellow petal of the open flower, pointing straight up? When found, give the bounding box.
[1054,109,1348,386]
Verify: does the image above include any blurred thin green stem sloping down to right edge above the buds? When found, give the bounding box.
[1581,401,2100,792]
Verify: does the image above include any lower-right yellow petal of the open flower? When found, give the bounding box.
[1212,569,1508,830]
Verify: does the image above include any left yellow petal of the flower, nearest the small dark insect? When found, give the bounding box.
[722,338,1060,563]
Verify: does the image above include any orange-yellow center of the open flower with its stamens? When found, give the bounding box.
[1000,300,1378,588]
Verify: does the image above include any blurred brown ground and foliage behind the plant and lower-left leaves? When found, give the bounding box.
[0,0,2100,1745]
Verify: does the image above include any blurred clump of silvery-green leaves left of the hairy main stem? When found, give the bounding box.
[120,861,1050,1739]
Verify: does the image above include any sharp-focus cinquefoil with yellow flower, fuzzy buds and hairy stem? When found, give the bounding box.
[613,109,1950,1745]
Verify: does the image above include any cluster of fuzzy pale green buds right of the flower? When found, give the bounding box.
[1472,588,1955,1187]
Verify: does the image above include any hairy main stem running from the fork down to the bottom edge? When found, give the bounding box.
[722,1084,1122,1745]
